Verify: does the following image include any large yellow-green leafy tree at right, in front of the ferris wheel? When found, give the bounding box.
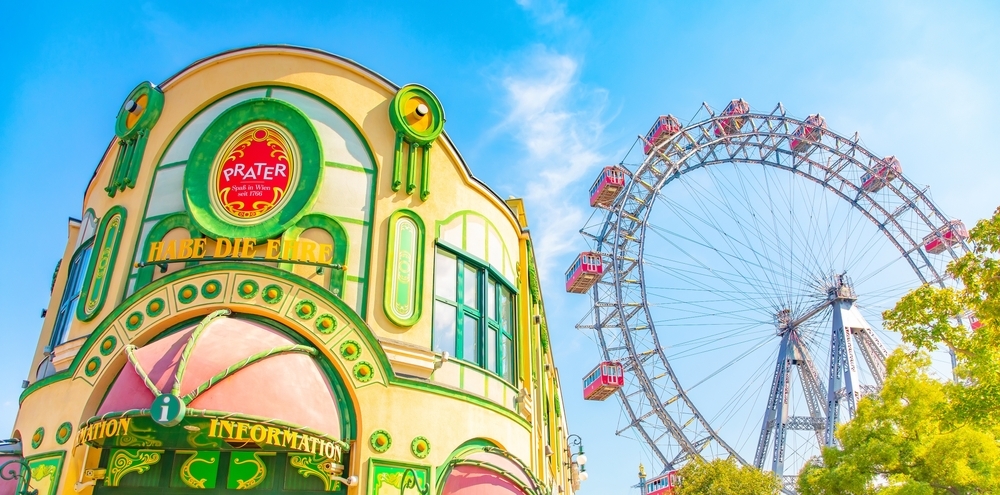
[799,209,1000,495]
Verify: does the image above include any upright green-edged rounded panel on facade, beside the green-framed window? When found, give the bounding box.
[382,209,425,327]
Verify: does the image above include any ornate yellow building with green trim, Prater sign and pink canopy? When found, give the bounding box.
[0,46,578,495]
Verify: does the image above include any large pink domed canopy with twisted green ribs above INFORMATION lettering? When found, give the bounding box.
[98,318,341,438]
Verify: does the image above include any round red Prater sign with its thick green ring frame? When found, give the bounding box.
[184,98,323,239]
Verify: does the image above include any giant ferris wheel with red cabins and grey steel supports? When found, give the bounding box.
[566,100,969,493]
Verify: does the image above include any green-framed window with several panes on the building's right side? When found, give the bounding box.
[433,248,516,384]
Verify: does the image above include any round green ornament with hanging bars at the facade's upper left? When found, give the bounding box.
[104,81,163,198]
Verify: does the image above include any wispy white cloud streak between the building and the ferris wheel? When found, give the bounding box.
[500,48,607,273]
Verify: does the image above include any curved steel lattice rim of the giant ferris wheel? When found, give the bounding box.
[592,105,969,476]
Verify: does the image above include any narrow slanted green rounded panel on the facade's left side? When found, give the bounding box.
[76,206,126,321]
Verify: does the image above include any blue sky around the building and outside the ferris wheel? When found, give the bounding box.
[0,0,1000,493]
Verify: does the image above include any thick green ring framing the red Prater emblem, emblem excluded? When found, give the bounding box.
[184,98,323,241]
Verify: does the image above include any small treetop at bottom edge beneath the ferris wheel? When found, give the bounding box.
[674,459,781,495]
